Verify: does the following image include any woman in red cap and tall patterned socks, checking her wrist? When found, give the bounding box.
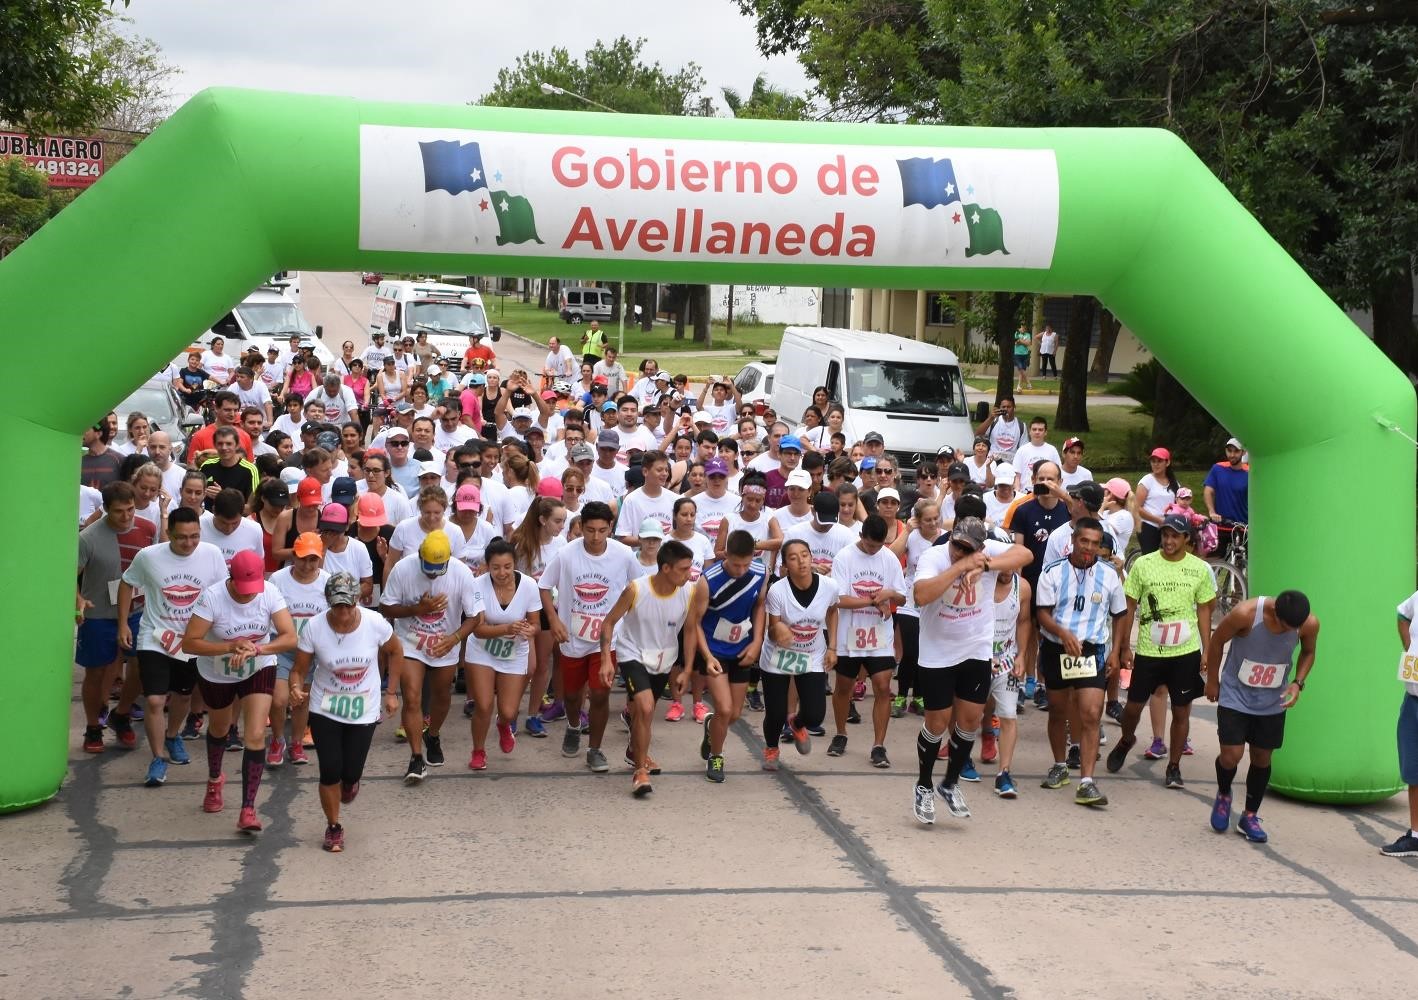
[182,549,295,833]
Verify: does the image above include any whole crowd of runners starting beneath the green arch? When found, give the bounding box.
[75,327,1407,851]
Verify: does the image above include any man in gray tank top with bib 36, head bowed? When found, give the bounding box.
[1207,590,1320,844]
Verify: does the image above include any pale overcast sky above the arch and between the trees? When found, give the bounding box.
[126,0,808,109]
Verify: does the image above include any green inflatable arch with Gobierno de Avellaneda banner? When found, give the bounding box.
[0,89,1418,810]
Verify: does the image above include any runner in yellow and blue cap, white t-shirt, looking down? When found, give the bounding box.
[380,530,479,784]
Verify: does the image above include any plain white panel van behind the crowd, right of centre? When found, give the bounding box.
[773,326,974,479]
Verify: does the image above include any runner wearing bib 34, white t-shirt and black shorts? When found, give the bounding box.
[827,513,906,769]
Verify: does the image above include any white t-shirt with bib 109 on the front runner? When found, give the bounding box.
[296,607,394,726]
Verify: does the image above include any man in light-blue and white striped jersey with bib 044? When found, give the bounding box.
[1034,518,1127,806]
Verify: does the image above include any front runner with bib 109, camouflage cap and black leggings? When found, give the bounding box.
[291,573,404,854]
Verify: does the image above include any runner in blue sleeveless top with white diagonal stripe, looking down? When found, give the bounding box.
[693,530,769,783]
